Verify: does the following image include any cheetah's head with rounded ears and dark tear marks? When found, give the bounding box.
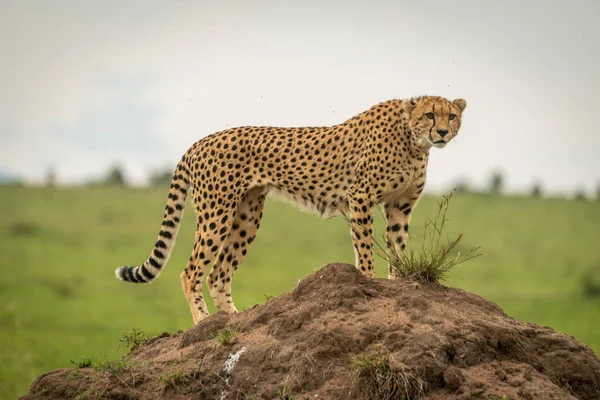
[402,96,467,148]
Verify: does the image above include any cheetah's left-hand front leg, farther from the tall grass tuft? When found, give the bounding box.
[348,191,375,278]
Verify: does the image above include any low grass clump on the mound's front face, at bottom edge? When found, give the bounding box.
[352,348,425,400]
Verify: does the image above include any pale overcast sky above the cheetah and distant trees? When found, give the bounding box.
[0,0,600,193]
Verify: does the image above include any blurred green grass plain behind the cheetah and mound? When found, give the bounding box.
[0,186,600,398]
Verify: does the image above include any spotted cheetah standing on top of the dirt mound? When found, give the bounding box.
[115,96,467,324]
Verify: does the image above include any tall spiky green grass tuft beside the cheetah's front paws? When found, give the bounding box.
[374,192,481,282]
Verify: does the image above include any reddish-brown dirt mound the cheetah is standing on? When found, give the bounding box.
[23,264,600,400]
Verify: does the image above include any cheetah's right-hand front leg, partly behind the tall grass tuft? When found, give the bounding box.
[384,196,420,279]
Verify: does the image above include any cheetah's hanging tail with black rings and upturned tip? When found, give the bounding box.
[115,154,190,283]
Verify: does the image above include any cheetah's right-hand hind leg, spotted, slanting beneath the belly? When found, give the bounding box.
[206,188,265,313]
